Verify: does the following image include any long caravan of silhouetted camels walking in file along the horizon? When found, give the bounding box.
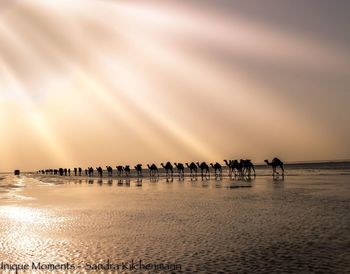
[37,158,284,177]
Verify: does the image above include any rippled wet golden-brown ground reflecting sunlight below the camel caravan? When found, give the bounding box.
[0,167,350,273]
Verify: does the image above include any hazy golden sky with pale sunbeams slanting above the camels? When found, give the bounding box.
[0,0,350,171]
